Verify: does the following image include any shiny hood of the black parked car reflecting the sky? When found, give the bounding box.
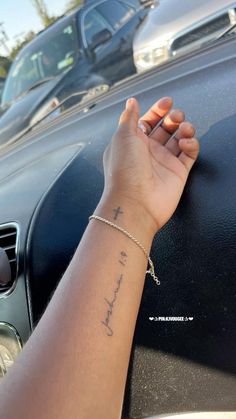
[0,76,62,144]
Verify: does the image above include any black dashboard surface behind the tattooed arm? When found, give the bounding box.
[0,37,236,418]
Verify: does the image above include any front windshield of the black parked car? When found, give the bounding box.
[2,23,78,105]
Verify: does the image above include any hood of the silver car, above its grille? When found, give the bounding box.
[133,0,236,52]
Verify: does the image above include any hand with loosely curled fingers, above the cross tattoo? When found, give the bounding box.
[103,97,199,234]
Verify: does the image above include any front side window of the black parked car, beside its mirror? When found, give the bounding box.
[84,8,112,45]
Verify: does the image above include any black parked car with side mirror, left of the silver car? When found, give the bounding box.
[0,0,148,144]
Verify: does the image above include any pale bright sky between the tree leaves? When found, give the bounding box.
[0,0,68,55]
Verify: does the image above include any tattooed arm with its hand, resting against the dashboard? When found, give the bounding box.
[0,98,199,419]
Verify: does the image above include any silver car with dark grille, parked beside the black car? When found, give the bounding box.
[133,0,236,72]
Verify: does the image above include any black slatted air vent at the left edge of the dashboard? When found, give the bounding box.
[0,224,17,293]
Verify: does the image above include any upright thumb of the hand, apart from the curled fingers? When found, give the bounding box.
[118,98,139,134]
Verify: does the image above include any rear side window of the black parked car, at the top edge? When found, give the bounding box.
[97,0,134,30]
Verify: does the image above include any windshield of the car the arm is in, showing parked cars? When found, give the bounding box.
[0,0,236,140]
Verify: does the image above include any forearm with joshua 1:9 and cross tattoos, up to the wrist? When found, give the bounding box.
[0,197,157,419]
